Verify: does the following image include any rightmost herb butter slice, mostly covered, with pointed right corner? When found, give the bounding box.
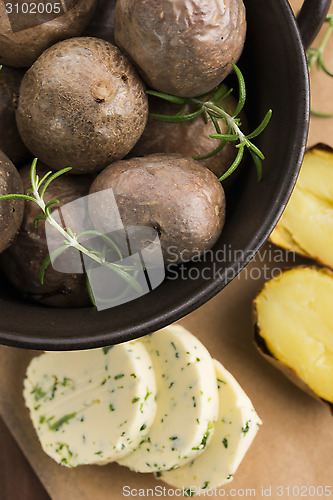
[157,360,261,496]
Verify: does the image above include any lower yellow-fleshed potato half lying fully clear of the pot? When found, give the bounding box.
[255,268,333,402]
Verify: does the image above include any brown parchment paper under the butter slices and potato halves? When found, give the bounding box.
[0,0,333,500]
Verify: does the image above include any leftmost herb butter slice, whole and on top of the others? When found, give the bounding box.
[24,342,156,467]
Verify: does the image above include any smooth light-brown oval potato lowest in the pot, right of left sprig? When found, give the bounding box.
[90,154,225,264]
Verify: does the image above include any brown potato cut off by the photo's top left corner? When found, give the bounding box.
[0,0,97,67]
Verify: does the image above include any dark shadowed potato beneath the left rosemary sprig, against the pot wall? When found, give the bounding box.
[1,163,92,307]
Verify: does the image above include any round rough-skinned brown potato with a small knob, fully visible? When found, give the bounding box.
[16,37,148,173]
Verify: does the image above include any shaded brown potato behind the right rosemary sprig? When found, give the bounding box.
[130,95,243,182]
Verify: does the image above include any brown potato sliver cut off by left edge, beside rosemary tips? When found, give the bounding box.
[0,151,24,253]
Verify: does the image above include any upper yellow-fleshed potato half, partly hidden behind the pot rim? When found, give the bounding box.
[271,148,333,268]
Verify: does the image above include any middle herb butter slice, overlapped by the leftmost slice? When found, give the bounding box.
[117,325,218,472]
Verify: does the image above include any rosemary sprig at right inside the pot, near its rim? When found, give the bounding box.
[146,64,272,181]
